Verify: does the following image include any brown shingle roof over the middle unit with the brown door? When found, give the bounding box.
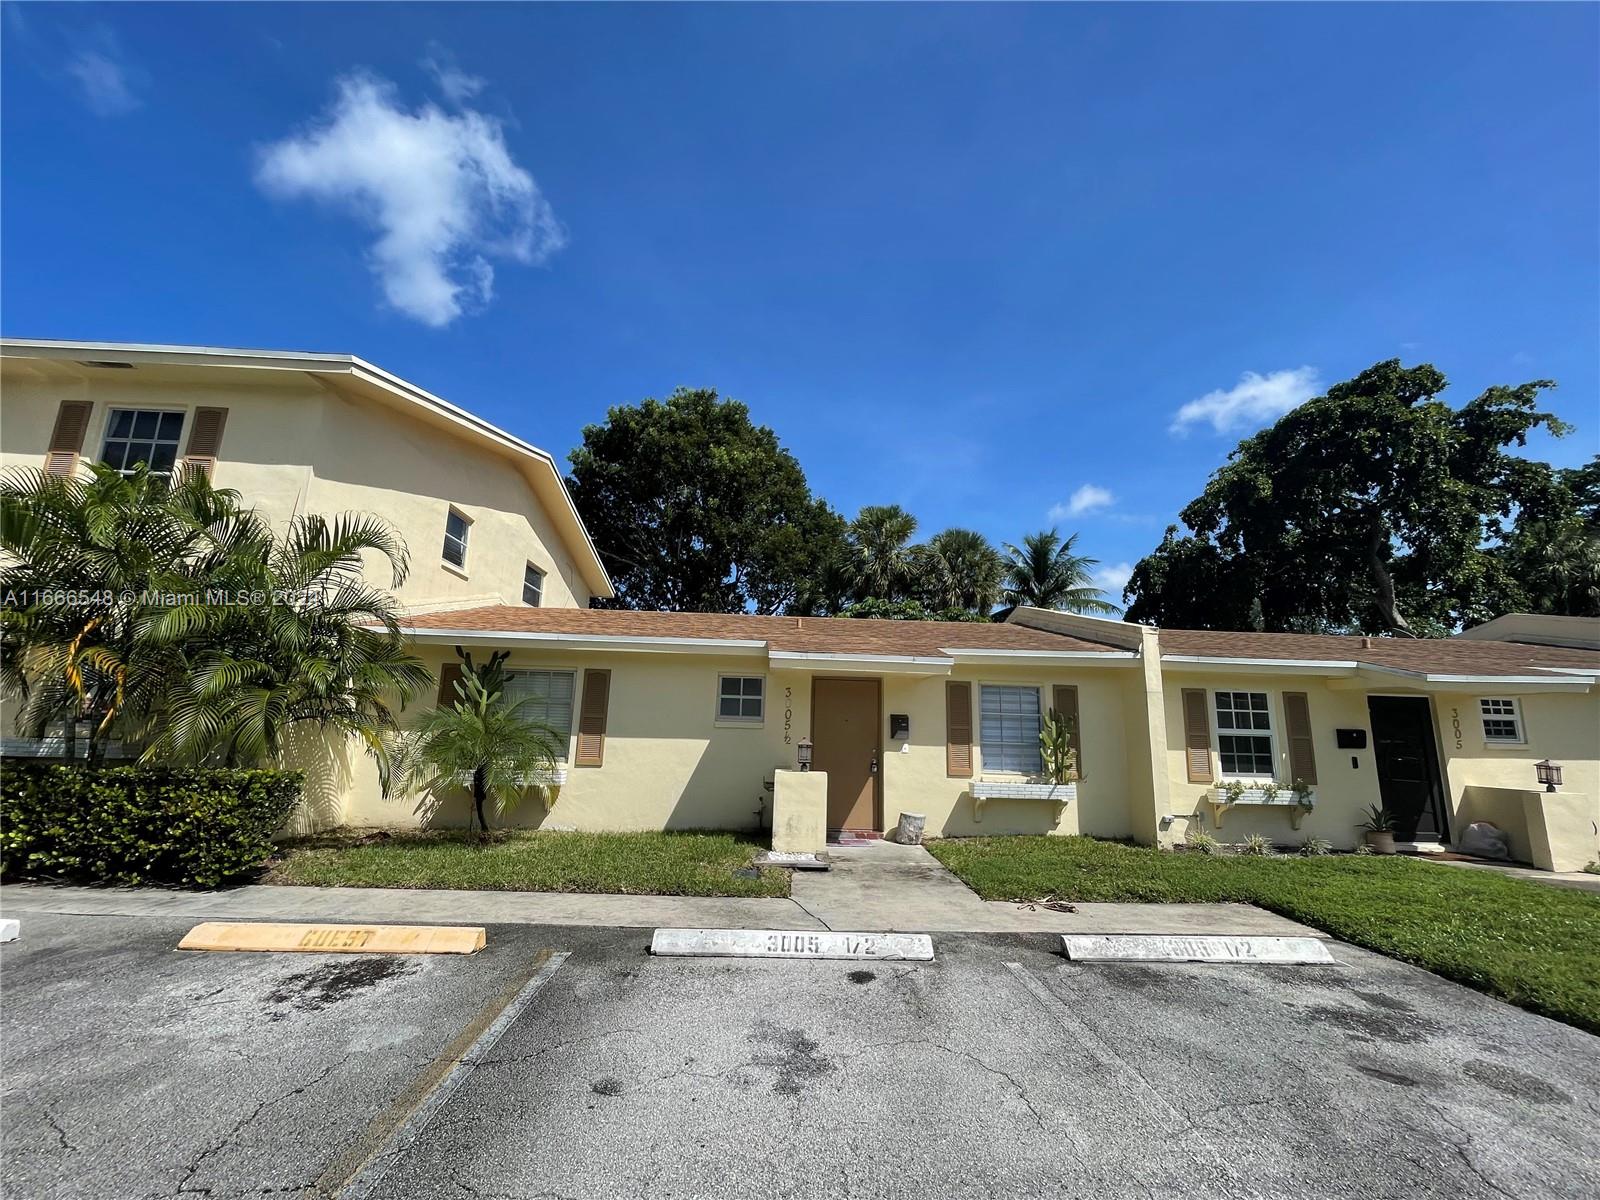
[400,605,1115,658]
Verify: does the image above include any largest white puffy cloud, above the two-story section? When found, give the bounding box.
[256,75,566,326]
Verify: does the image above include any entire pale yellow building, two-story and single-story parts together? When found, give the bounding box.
[0,341,1600,869]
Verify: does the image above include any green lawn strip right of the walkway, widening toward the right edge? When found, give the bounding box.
[928,837,1600,1034]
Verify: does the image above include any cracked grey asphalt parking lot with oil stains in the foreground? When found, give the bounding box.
[0,914,1600,1200]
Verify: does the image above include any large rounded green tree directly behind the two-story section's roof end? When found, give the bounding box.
[568,389,845,613]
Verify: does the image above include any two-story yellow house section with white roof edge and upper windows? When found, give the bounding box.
[0,339,611,611]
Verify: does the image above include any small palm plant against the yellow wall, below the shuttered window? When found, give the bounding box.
[384,650,560,834]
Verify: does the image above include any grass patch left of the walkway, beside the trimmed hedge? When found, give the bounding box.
[267,830,789,896]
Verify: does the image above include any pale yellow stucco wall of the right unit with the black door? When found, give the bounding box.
[1162,670,1600,861]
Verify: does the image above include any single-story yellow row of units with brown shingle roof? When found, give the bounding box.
[318,606,1600,870]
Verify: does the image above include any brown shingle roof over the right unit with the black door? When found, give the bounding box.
[1160,629,1600,675]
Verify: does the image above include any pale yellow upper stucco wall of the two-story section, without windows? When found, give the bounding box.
[0,360,590,608]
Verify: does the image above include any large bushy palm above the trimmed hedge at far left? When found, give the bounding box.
[0,467,430,765]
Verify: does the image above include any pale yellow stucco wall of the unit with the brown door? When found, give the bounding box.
[328,645,1138,837]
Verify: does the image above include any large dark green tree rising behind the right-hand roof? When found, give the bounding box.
[1125,360,1565,634]
